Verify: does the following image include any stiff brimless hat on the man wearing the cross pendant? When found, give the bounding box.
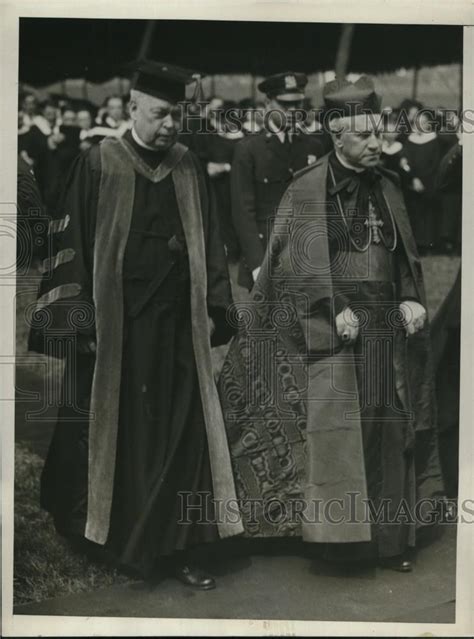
[323,76,382,117]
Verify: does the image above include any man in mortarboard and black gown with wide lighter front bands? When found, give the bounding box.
[30,61,241,589]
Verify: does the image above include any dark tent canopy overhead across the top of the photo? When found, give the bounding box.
[20,18,463,86]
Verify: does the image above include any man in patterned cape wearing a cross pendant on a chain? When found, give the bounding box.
[220,77,443,572]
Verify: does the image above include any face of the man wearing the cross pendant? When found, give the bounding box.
[333,115,382,168]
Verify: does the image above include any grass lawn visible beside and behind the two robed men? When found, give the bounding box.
[14,257,459,604]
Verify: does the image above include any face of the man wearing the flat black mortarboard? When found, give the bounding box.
[130,92,181,150]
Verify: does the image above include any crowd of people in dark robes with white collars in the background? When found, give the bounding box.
[18,85,461,270]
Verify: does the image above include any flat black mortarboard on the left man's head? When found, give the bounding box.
[127,59,202,102]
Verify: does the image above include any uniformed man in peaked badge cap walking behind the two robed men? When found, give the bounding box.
[231,72,324,289]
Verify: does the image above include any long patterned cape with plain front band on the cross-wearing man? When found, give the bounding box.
[219,155,443,556]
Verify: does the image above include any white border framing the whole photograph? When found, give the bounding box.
[0,0,474,637]
